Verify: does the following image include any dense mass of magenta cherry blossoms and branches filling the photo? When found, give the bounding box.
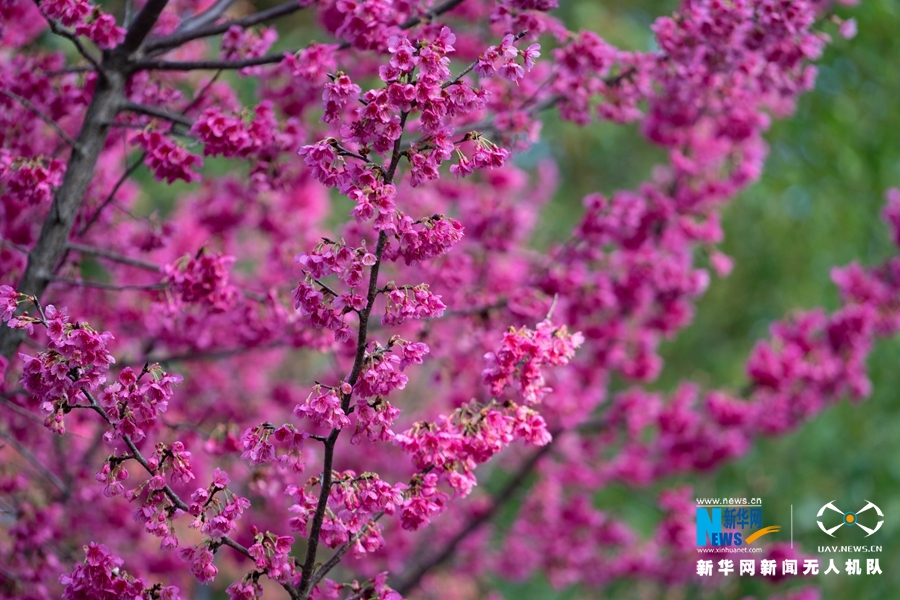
[0,0,884,600]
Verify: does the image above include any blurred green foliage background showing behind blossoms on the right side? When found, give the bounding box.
[498,0,900,600]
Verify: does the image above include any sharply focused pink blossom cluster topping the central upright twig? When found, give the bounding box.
[300,27,538,233]
